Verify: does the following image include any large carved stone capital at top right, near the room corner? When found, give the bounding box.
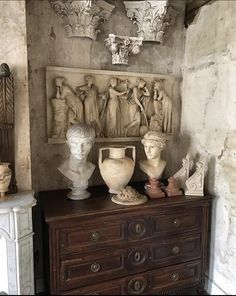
[124,0,177,43]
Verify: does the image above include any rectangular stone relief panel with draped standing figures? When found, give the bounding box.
[46,66,174,143]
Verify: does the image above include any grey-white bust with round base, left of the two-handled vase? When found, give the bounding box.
[58,123,95,200]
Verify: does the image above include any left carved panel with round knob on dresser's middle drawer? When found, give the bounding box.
[59,248,125,291]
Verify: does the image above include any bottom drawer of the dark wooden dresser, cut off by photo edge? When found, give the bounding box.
[64,261,201,295]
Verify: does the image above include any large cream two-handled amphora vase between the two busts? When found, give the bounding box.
[98,145,135,194]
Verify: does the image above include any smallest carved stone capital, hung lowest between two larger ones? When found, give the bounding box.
[104,34,143,65]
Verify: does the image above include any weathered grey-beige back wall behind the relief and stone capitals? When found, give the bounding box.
[27,0,184,191]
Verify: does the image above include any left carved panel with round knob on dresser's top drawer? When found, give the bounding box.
[59,221,124,255]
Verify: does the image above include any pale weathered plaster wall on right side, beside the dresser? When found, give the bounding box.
[181,1,236,295]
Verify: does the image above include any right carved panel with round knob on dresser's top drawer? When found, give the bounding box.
[154,207,202,234]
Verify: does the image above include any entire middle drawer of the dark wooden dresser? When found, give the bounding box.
[60,235,201,290]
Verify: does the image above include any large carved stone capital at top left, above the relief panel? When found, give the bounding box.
[49,0,115,40]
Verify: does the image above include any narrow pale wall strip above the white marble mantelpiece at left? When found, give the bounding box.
[0,1,31,190]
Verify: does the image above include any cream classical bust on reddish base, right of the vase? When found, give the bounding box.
[139,131,167,180]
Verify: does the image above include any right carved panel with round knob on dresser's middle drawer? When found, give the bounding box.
[151,234,201,266]
